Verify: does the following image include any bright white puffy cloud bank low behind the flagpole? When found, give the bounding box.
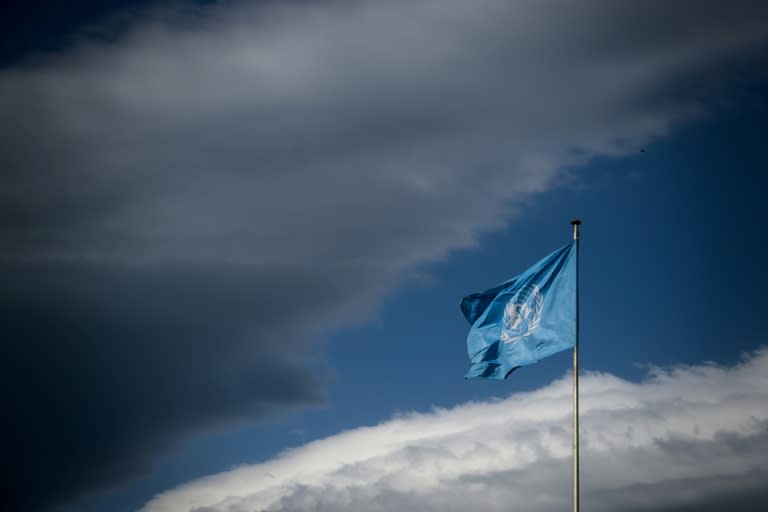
[142,349,768,512]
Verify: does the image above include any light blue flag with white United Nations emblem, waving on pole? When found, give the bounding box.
[461,241,576,380]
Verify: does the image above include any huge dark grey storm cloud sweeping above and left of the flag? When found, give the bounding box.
[0,0,766,506]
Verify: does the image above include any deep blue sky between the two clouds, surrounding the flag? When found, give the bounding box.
[67,94,768,510]
